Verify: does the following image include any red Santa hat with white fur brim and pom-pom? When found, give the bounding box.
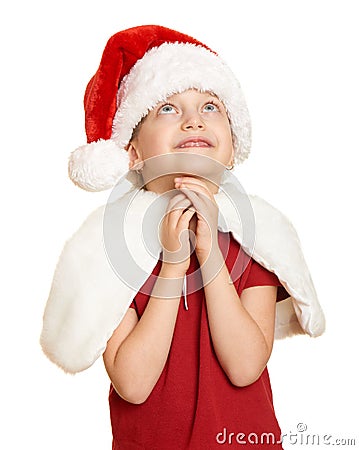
[69,25,251,191]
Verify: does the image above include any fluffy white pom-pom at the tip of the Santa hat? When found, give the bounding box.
[68,139,129,192]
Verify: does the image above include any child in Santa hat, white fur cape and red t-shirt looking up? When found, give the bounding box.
[41,26,324,450]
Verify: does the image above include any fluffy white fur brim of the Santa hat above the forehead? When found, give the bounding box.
[112,42,251,163]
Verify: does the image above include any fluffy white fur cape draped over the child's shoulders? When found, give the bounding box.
[40,172,325,373]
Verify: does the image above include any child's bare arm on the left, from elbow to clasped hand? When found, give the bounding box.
[104,194,194,404]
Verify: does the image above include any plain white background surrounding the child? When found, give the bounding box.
[0,0,359,450]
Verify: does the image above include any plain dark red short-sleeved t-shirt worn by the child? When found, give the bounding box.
[109,232,288,450]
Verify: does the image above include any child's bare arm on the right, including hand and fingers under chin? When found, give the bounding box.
[175,177,277,386]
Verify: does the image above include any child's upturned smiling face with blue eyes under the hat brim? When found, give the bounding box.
[128,89,233,191]
